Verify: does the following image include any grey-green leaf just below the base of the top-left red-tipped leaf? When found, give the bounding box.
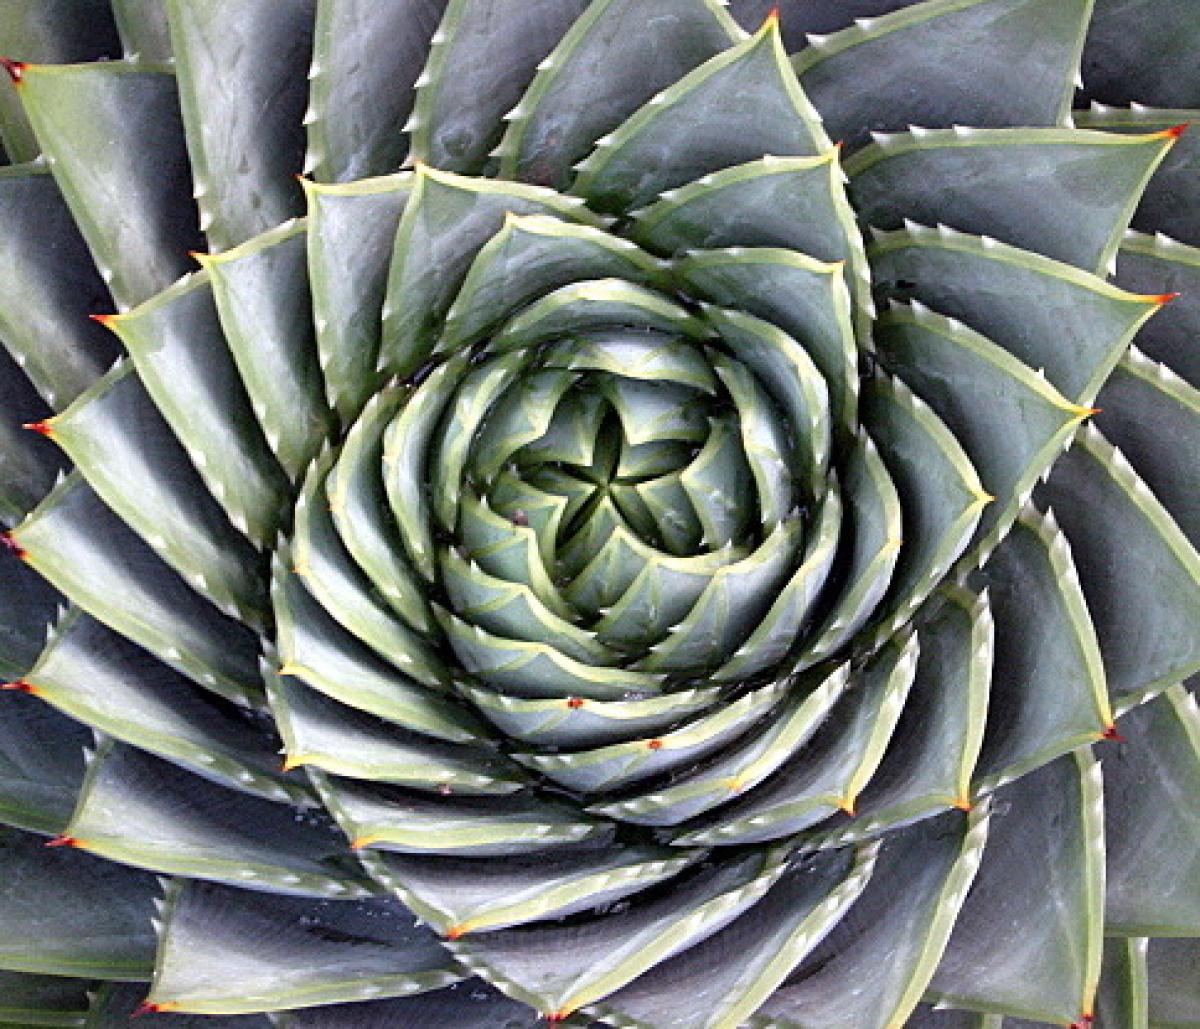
[104,272,288,547]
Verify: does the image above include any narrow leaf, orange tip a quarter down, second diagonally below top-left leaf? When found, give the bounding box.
[197,221,332,480]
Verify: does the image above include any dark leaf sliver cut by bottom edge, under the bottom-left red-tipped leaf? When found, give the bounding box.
[272,979,540,1029]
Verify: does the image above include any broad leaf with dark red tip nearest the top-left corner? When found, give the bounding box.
[20,61,199,309]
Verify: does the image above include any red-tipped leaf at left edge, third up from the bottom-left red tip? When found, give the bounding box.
[26,608,313,806]
